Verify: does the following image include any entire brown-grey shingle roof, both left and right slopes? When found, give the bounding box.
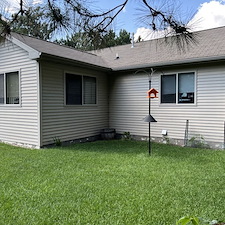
[12,27,225,71]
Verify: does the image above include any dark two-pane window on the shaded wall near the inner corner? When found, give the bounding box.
[66,73,96,105]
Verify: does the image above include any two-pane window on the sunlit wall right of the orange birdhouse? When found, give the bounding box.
[161,72,195,104]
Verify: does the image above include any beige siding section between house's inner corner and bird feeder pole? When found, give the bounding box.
[109,74,149,135]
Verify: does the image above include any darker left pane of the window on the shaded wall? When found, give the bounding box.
[66,74,82,105]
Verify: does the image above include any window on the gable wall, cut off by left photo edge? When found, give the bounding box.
[0,72,20,104]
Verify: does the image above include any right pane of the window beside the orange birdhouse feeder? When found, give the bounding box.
[178,73,195,104]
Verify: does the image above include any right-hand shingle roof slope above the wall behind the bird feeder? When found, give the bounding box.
[93,27,225,70]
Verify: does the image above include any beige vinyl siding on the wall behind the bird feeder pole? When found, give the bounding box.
[109,65,225,148]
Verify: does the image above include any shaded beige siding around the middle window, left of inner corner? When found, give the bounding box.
[41,62,109,145]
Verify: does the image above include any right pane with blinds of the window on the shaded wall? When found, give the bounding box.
[83,76,96,104]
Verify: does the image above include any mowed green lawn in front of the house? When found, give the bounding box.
[0,141,225,225]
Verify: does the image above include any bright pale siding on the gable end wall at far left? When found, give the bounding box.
[0,41,39,147]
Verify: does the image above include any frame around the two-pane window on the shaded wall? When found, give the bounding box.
[64,71,98,107]
